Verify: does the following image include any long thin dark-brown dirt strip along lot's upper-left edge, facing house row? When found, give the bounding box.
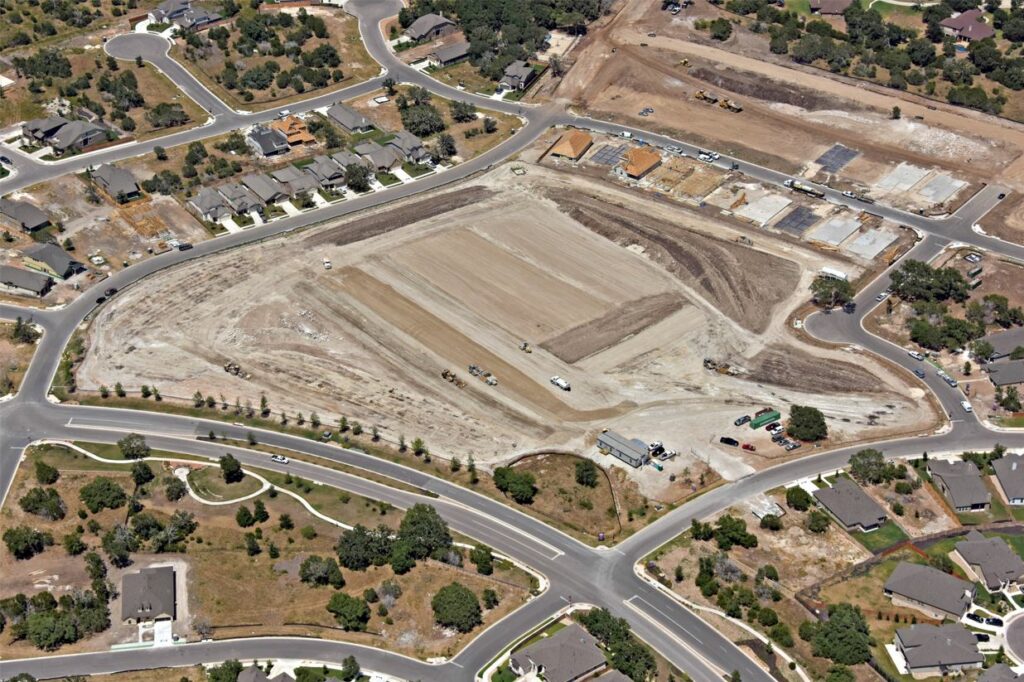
[306,185,495,247]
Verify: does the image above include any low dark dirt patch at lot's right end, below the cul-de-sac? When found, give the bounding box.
[748,346,883,393]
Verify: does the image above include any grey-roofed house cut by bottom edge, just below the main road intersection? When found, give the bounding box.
[509,623,607,682]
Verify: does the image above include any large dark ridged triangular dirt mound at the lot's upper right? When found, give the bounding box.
[550,189,800,333]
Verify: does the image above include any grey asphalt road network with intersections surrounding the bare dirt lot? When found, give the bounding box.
[0,0,1024,682]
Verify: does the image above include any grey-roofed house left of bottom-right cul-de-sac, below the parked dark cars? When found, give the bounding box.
[893,624,985,679]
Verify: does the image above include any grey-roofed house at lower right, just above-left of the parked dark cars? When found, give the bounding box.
[884,561,975,621]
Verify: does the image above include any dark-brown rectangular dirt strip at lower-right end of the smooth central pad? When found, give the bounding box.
[541,293,686,364]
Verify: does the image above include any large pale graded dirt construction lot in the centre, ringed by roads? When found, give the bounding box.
[79,166,931,473]
